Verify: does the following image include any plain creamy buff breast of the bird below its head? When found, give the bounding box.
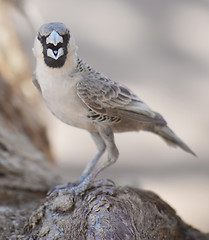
[39,73,94,130]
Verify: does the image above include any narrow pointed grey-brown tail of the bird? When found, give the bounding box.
[154,126,196,156]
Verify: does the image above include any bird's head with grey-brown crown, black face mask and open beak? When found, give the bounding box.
[33,22,77,68]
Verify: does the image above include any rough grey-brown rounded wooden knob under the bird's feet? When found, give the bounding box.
[24,185,209,240]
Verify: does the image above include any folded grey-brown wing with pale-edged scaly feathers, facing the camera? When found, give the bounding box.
[77,75,166,125]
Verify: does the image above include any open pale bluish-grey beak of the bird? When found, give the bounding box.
[46,30,64,60]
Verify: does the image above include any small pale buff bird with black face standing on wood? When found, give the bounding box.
[32,22,196,193]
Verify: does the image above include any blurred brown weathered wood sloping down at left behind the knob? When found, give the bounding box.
[0,77,60,239]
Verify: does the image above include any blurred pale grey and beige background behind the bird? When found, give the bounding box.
[0,0,209,232]
